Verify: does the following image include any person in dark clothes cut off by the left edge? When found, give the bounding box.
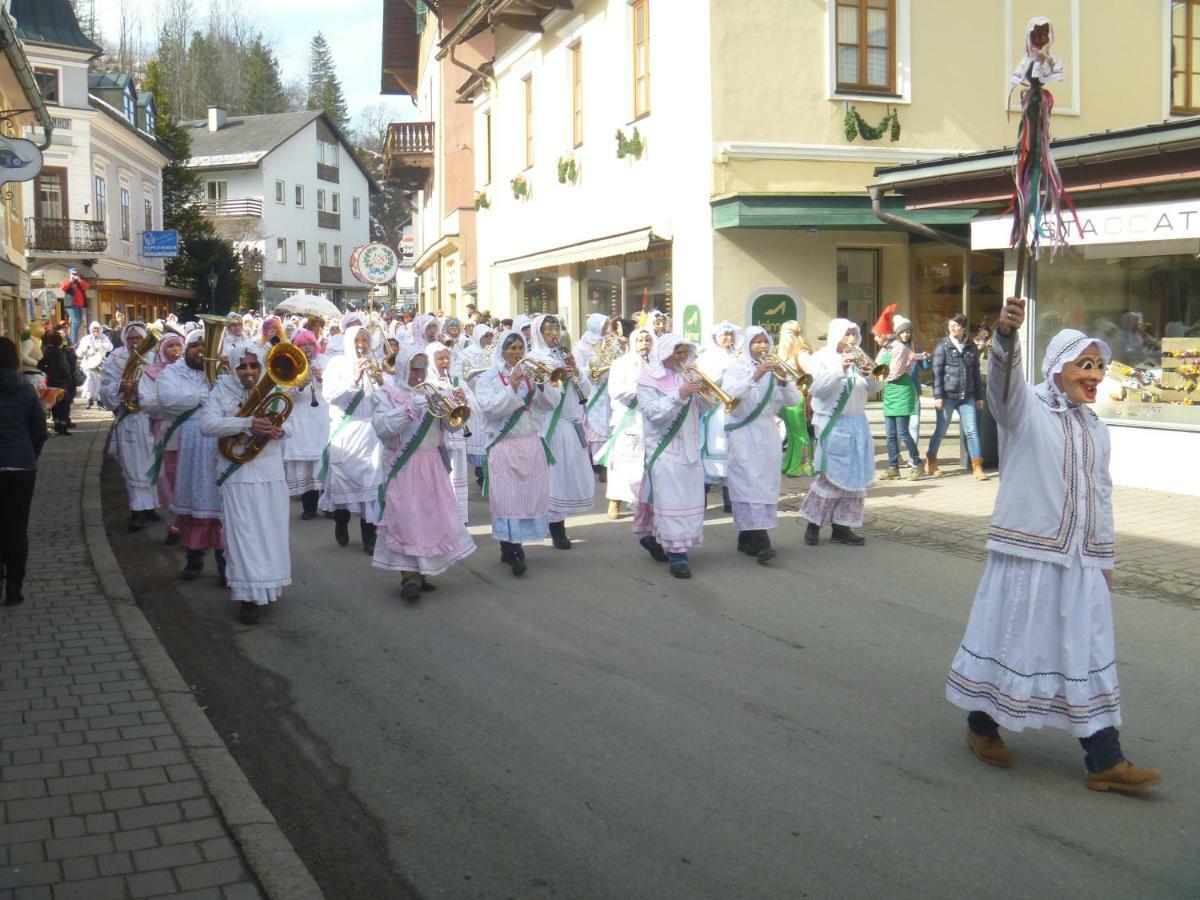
[0,337,46,606]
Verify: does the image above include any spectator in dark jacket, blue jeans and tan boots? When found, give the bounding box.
[925,313,988,481]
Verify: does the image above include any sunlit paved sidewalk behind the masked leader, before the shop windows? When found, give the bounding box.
[780,458,1200,608]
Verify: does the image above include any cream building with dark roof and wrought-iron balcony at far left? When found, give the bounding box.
[12,0,192,320]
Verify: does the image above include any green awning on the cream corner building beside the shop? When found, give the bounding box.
[713,194,980,230]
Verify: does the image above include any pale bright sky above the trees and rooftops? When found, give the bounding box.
[96,0,415,128]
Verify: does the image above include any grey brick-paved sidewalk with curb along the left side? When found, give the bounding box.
[0,404,319,900]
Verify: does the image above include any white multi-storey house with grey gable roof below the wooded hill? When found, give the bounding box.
[187,107,378,310]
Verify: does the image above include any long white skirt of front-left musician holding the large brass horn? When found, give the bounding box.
[221,481,292,606]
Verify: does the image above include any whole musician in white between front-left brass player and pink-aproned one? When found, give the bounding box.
[318,325,384,553]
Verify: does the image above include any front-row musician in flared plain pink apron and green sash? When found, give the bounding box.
[371,343,475,602]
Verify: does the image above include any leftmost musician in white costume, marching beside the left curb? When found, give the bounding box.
[100,322,158,532]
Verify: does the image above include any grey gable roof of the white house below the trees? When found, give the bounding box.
[180,109,379,191]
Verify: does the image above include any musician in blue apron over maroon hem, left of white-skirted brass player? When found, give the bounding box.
[158,329,225,587]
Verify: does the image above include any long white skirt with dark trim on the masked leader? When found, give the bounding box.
[946,552,1121,738]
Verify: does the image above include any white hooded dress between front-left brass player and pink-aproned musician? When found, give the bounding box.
[320,325,384,524]
